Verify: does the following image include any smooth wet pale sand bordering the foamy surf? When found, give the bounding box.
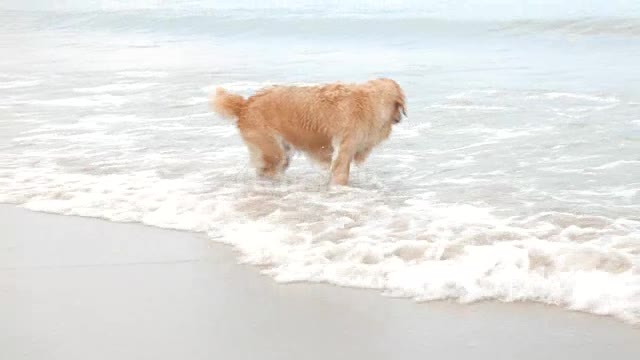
[0,205,640,360]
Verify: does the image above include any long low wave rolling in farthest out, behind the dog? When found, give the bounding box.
[3,8,640,39]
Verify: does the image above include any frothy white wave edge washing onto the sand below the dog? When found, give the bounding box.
[0,172,640,323]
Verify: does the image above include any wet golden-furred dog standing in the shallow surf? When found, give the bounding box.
[210,78,407,186]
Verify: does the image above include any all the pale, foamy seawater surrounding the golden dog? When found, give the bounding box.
[0,1,640,323]
